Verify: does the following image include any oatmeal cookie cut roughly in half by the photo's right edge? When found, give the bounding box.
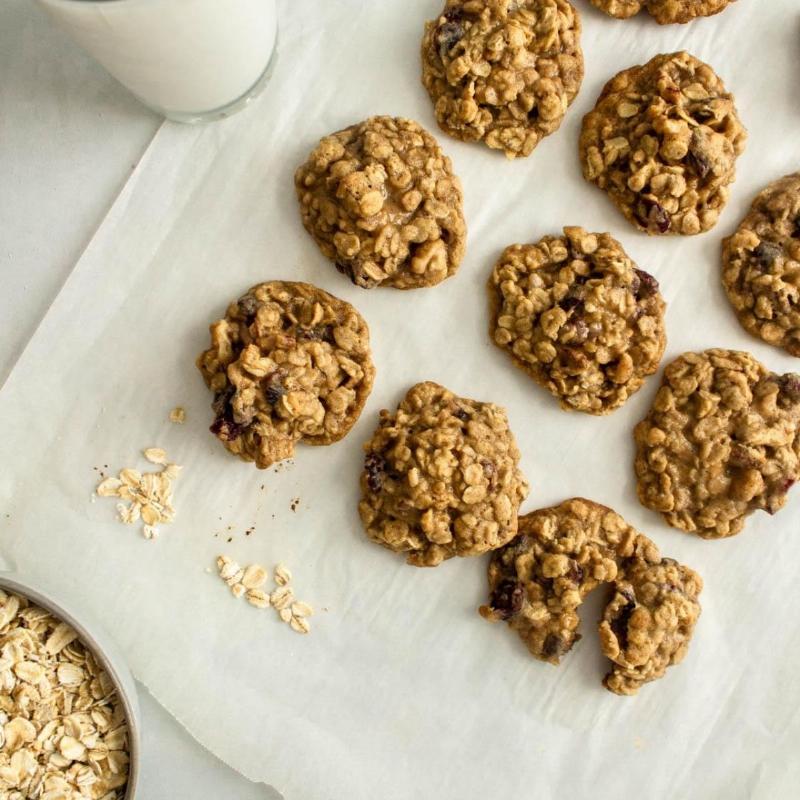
[722,172,800,356]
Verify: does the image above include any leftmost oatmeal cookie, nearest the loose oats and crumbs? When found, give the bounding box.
[197,281,375,469]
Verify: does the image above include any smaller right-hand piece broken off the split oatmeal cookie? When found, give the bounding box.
[600,558,703,694]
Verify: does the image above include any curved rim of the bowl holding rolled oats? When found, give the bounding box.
[0,571,141,800]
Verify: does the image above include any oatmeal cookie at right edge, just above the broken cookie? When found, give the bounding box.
[634,350,800,539]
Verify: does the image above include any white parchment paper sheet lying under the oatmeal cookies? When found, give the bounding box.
[0,0,800,800]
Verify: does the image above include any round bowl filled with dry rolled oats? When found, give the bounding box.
[0,573,140,800]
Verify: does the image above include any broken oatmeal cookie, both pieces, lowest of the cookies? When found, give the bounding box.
[480,498,702,694]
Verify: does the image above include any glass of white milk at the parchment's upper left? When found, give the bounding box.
[38,0,278,122]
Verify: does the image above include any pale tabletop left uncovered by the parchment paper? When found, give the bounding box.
[0,0,278,800]
